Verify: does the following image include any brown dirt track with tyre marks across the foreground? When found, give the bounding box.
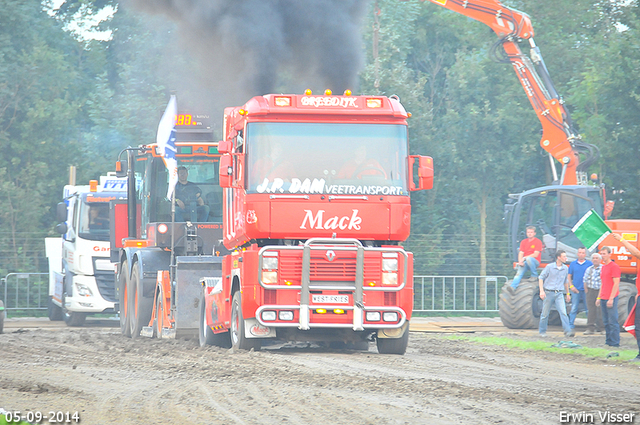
[0,318,640,425]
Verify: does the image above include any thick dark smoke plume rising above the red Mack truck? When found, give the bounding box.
[130,0,368,101]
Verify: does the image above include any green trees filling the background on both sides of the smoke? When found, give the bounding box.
[0,0,640,274]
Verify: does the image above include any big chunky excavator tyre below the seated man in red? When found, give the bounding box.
[498,279,542,329]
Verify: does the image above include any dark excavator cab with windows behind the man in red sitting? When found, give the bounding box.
[505,185,604,264]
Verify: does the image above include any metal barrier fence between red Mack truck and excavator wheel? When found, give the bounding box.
[413,276,507,312]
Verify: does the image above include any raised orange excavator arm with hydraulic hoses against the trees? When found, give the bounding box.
[422,0,599,185]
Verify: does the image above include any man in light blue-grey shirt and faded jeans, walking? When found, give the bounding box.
[538,250,575,337]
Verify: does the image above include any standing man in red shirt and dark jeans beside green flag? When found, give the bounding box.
[596,246,620,347]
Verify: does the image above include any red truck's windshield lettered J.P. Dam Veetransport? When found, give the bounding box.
[246,123,408,195]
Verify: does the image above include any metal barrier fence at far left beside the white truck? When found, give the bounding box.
[1,273,49,316]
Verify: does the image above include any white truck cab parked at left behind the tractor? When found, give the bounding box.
[45,173,127,326]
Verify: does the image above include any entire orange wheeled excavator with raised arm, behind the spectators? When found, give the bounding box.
[408,0,640,329]
